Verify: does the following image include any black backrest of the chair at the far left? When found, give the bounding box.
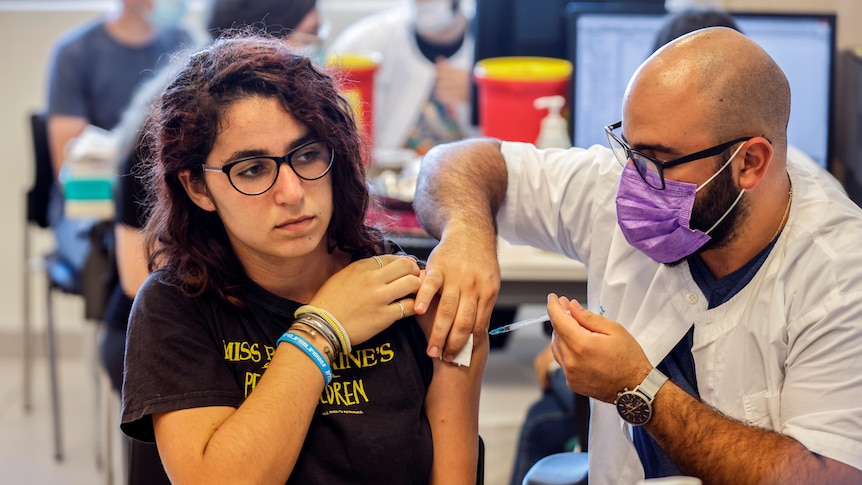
[27,113,54,227]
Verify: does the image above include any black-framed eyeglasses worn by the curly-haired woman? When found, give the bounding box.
[201,140,335,195]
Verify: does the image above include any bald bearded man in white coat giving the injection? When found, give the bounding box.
[415,27,862,484]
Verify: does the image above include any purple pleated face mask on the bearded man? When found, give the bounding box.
[616,145,745,263]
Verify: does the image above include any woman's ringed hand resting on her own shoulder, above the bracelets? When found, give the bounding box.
[309,255,420,344]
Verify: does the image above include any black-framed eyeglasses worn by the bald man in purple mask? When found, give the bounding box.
[605,121,754,190]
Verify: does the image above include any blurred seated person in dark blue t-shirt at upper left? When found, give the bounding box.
[46,0,193,288]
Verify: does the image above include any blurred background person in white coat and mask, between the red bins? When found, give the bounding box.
[329,0,475,155]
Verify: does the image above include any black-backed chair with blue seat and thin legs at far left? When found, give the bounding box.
[23,113,115,468]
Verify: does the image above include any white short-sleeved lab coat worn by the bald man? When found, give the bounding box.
[497,143,862,484]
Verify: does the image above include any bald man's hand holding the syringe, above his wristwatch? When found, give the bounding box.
[548,294,653,402]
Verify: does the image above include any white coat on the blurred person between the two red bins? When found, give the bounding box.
[329,6,476,149]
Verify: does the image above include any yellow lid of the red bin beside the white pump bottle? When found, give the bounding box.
[473,57,572,82]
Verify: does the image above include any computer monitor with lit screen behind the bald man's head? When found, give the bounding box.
[566,2,835,168]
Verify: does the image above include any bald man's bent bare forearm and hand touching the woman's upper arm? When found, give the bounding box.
[413,139,507,361]
